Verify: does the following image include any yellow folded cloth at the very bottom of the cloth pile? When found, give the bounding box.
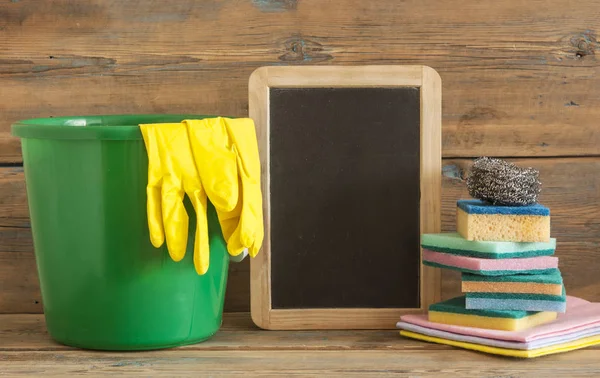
[400,331,600,358]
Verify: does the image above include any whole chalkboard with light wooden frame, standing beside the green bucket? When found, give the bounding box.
[250,66,441,329]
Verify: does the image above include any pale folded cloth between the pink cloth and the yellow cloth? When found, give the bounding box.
[397,322,600,350]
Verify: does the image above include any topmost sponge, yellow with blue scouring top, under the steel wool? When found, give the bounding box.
[456,200,550,242]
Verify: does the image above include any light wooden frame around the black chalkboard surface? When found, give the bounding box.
[249,65,442,330]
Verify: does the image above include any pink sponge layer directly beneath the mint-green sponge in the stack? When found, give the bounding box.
[423,249,558,272]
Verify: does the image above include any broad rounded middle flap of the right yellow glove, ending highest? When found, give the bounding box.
[184,117,239,211]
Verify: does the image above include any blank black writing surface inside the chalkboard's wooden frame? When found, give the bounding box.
[269,87,421,309]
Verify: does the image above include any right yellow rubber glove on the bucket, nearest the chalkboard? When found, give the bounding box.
[184,117,264,257]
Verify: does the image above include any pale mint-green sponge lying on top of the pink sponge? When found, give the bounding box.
[421,232,556,259]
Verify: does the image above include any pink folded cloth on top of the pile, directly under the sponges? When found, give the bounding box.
[400,296,600,343]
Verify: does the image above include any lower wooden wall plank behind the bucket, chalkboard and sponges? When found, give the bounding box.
[0,157,600,313]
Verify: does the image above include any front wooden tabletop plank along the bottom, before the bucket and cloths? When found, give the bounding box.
[0,350,600,378]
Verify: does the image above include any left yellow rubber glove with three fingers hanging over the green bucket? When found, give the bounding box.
[140,123,210,274]
